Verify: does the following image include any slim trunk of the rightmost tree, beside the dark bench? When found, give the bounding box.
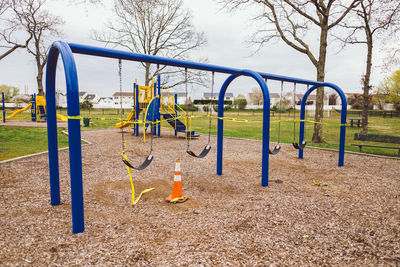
[361,27,373,134]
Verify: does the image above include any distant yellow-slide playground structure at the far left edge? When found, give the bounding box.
[1,92,68,123]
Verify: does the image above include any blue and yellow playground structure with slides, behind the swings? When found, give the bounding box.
[115,75,199,142]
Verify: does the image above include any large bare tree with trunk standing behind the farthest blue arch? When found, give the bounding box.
[220,0,360,143]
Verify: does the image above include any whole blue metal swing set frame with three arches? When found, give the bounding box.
[46,41,347,233]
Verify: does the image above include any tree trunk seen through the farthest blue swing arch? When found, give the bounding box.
[312,26,328,143]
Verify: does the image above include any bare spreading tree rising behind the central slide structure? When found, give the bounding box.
[92,0,206,87]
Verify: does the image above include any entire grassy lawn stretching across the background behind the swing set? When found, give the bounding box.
[0,109,400,159]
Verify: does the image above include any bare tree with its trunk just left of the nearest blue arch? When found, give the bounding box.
[11,0,64,95]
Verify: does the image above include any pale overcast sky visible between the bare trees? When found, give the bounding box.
[0,0,390,98]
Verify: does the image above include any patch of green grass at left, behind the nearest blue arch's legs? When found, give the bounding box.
[0,126,68,160]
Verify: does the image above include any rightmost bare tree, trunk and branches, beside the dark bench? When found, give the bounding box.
[342,0,400,134]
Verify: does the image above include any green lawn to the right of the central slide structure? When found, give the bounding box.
[188,111,400,156]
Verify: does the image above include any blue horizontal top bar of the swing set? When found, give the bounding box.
[68,43,326,86]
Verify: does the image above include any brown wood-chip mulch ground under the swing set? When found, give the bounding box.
[0,129,400,266]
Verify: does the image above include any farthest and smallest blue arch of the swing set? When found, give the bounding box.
[299,83,347,167]
